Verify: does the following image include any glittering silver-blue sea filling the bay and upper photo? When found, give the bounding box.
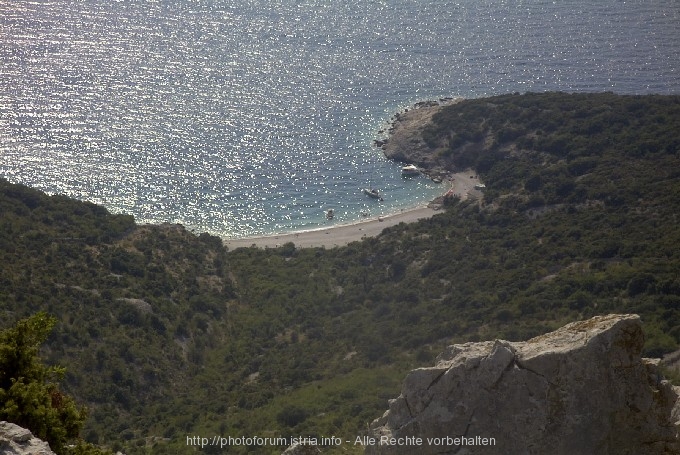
[0,0,680,238]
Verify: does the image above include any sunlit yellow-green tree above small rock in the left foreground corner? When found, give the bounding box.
[0,312,103,455]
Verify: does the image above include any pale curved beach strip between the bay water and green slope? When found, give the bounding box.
[223,171,481,250]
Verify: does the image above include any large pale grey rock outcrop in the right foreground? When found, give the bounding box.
[366,315,680,455]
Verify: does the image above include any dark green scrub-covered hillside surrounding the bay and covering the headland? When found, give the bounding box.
[0,93,680,455]
